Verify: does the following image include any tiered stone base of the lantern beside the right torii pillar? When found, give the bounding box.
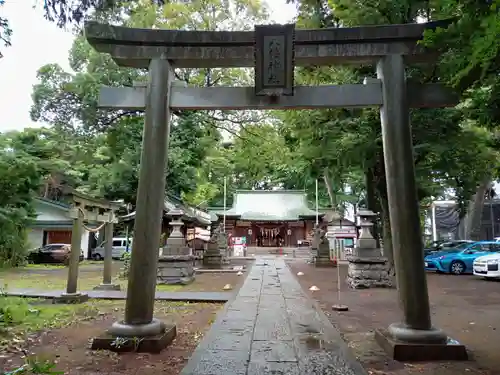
[347,257,393,289]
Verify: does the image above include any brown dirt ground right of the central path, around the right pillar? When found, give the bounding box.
[287,260,500,375]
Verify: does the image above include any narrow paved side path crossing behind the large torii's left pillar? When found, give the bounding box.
[3,288,233,302]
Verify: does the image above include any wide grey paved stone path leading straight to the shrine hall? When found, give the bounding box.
[181,256,366,375]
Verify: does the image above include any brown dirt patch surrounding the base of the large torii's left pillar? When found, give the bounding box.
[0,301,223,375]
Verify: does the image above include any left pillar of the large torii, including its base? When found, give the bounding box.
[92,58,176,352]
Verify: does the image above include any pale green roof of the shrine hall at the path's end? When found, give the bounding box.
[214,190,324,221]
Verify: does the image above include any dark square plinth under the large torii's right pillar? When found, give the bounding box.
[375,329,469,361]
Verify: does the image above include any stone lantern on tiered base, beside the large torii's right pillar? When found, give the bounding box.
[347,209,392,289]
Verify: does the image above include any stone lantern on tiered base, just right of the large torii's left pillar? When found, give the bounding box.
[156,209,195,285]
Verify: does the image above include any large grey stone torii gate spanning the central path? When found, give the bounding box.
[85,22,457,357]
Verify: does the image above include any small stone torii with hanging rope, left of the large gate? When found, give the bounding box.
[55,191,123,303]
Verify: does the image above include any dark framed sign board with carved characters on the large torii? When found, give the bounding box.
[254,24,295,96]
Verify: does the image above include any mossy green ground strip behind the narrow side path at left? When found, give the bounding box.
[0,261,251,292]
